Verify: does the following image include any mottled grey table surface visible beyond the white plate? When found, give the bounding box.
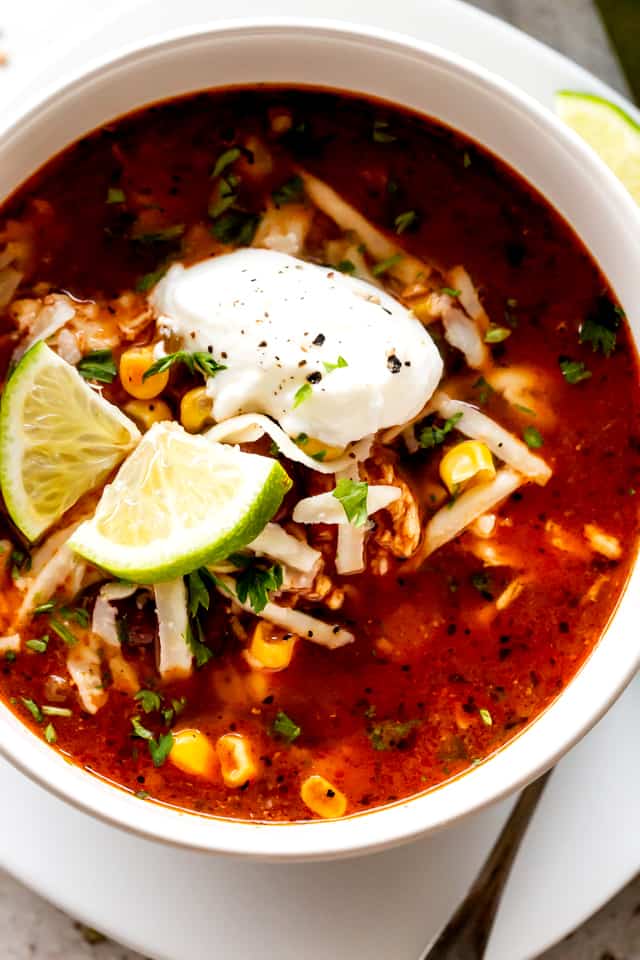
[0,0,640,960]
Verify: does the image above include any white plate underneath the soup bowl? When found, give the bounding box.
[0,0,640,960]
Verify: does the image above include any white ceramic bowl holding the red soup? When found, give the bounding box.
[0,20,640,860]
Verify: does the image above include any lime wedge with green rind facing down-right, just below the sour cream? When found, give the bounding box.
[69,421,291,583]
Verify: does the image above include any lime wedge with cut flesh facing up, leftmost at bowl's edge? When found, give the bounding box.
[0,340,140,540]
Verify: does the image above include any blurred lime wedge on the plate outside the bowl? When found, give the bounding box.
[556,90,640,203]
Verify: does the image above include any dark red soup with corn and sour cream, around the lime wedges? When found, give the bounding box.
[0,87,640,820]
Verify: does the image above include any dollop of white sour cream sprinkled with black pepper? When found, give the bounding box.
[151,249,442,447]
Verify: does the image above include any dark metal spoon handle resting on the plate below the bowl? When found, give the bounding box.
[420,770,552,960]
